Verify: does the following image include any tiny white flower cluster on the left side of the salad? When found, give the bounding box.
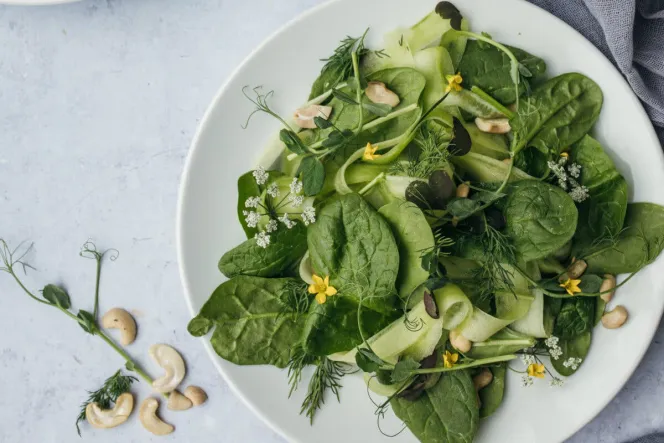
[242,170,316,248]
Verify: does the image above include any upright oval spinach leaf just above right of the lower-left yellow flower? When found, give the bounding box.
[307,194,399,313]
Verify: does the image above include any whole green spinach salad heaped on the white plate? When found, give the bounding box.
[188,2,664,443]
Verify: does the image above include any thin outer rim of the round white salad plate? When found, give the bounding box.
[176,0,664,441]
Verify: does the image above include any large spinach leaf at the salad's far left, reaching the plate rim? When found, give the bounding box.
[187,276,308,368]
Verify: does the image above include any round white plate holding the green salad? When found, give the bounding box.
[177,0,664,443]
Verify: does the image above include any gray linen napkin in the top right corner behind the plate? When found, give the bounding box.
[528,0,664,146]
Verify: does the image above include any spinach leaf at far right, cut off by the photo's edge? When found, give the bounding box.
[583,203,664,274]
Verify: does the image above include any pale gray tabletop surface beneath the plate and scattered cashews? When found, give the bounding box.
[0,0,664,443]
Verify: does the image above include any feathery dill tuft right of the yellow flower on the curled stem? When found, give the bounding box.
[390,124,450,179]
